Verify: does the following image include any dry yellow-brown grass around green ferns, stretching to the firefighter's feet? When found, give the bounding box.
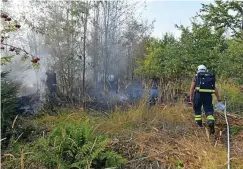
[30,103,243,169]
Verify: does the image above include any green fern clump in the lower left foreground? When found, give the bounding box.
[26,122,125,169]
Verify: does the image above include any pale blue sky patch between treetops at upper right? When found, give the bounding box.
[143,0,213,37]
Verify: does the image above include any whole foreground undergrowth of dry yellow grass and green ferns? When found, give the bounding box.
[2,90,243,169]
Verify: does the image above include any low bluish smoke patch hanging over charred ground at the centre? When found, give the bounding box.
[87,76,145,111]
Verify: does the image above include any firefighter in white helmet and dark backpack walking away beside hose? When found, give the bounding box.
[190,65,221,135]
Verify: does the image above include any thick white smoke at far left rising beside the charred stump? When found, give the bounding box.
[1,29,49,114]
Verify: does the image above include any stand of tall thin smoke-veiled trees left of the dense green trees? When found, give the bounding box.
[19,1,154,107]
